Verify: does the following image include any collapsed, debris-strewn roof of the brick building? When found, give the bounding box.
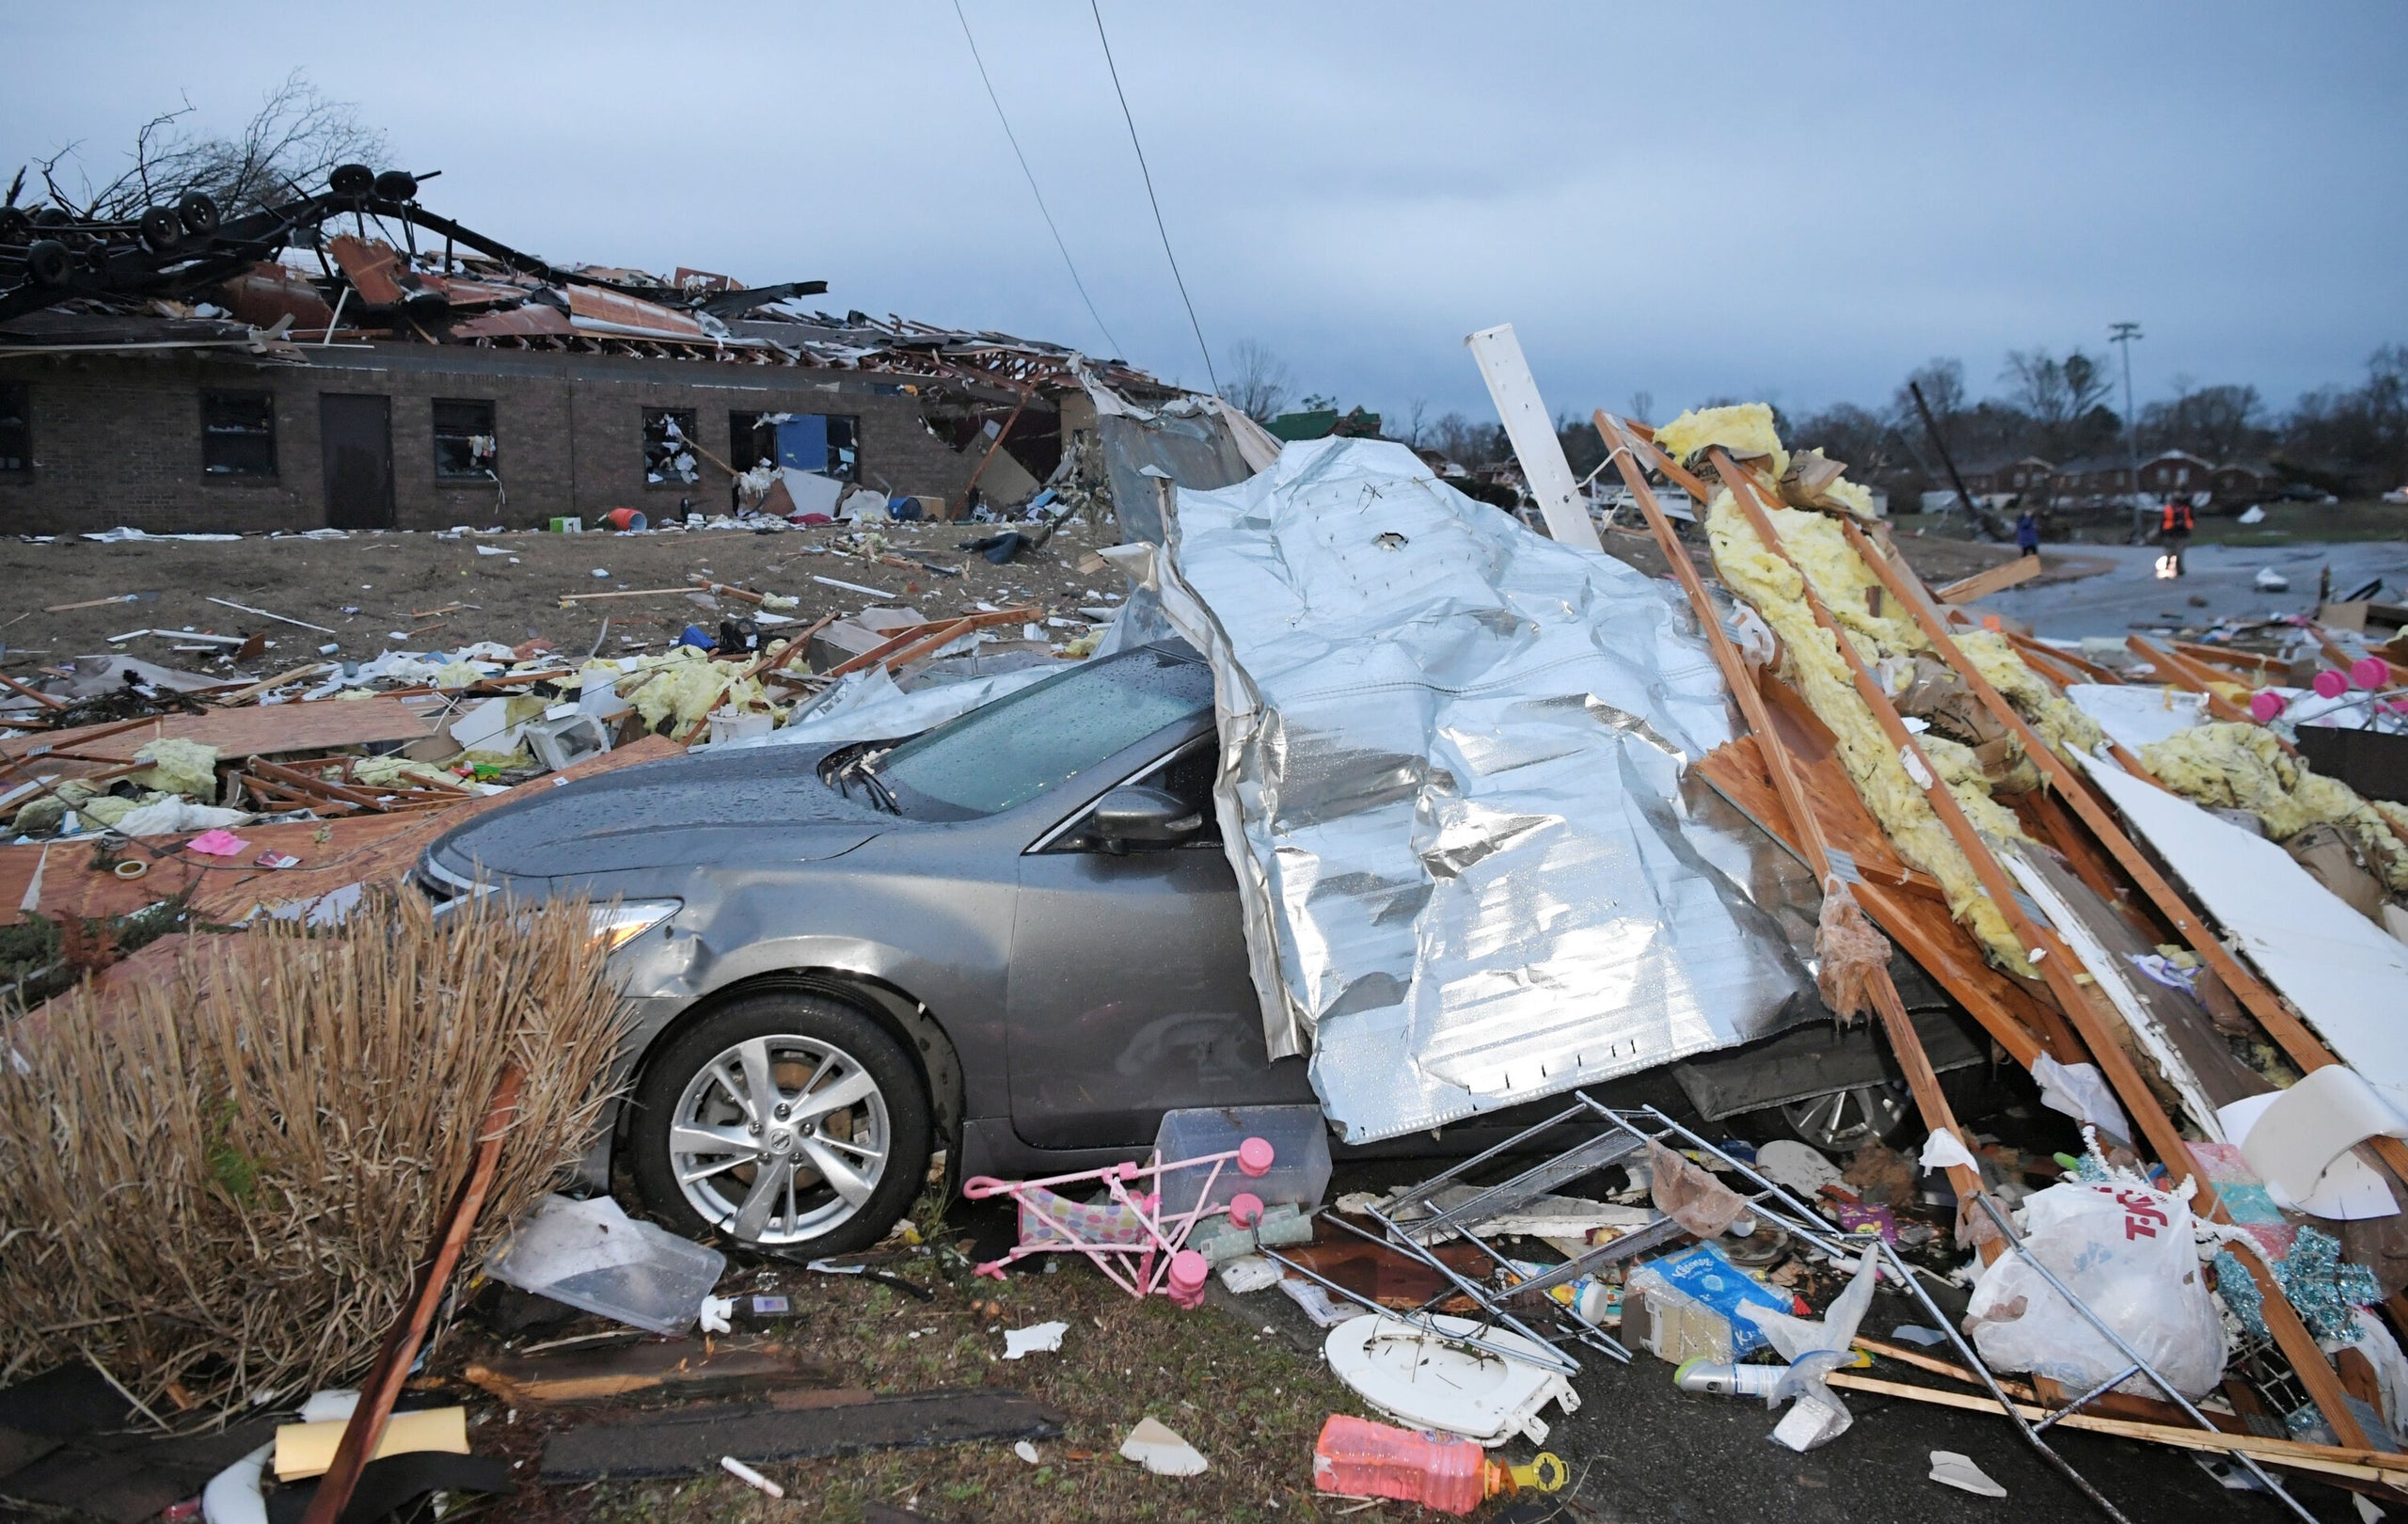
[0,164,1175,397]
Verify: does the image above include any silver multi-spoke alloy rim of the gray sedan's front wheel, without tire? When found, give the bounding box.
[670,1033,894,1247]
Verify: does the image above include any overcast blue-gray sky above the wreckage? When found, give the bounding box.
[0,0,2408,431]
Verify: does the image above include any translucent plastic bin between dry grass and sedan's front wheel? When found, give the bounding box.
[484,1197,727,1334]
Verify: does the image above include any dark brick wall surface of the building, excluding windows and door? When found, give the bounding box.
[0,344,1011,534]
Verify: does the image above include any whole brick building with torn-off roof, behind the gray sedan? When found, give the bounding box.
[0,182,1175,534]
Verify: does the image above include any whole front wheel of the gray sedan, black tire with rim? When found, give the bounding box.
[628,990,934,1257]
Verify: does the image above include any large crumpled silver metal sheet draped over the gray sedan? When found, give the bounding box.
[1146,438,1811,1141]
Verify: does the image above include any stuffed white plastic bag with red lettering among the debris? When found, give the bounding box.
[1965,1183,2225,1396]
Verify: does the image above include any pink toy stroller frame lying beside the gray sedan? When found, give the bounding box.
[960,1139,1272,1308]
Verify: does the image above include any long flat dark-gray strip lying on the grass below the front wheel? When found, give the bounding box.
[542,1387,1067,1481]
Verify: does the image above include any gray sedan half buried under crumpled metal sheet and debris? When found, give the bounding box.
[417,645,1972,1254]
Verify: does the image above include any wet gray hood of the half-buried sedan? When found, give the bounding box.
[431,746,908,879]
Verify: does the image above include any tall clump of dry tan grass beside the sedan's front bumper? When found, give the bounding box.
[0,893,621,1411]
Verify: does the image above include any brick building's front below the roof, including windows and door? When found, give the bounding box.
[0,344,1025,534]
